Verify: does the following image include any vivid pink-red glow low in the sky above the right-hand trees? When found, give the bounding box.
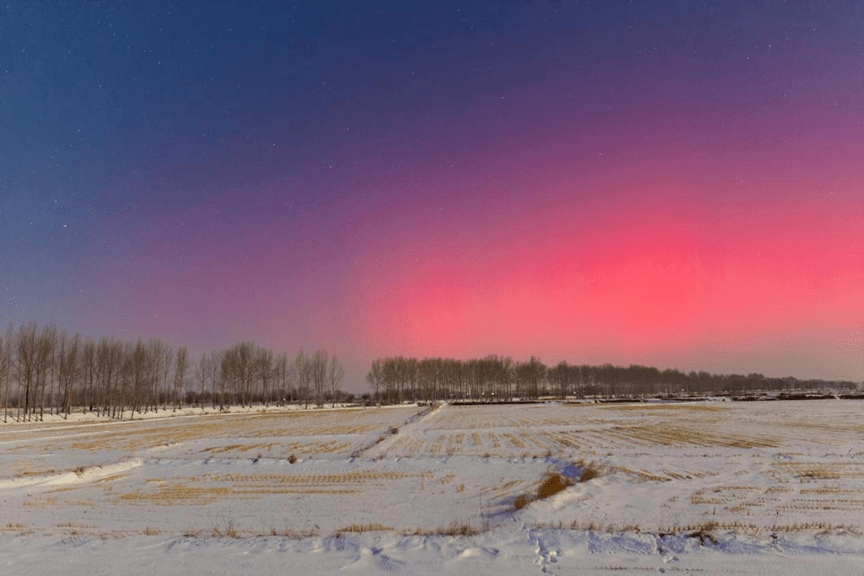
[359,174,864,374]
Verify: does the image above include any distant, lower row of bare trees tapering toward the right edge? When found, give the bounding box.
[366,355,857,403]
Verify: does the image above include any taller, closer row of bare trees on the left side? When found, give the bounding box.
[0,322,345,422]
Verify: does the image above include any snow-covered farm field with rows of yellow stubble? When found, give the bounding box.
[0,400,864,576]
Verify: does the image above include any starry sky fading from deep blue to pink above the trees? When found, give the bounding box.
[0,0,864,390]
